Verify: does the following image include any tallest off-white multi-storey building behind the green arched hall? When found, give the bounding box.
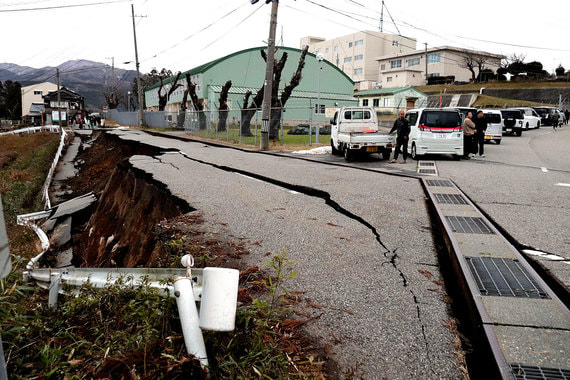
[301,30,416,90]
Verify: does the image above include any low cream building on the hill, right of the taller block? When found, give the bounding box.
[376,46,505,88]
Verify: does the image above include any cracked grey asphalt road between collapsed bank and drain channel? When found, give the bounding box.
[111,131,462,379]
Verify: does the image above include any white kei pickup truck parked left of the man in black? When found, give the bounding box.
[331,107,394,161]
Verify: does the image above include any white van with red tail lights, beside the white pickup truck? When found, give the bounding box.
[406,108,463,160]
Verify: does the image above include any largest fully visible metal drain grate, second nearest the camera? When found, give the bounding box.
[467,257,550,298]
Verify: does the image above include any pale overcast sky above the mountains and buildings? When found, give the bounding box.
[0,0,570,73]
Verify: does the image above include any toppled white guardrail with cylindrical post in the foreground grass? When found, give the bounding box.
[23,255,239,367]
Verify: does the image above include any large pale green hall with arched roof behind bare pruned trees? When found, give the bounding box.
[145,47,357,124]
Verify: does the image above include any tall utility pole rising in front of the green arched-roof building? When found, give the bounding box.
[260,0,279,150]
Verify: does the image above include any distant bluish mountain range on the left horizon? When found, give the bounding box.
[0,59,136,110]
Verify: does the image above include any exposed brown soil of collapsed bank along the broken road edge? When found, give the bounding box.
[56,130,328,378]
